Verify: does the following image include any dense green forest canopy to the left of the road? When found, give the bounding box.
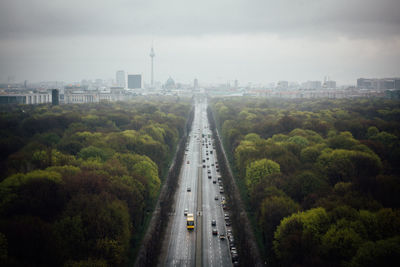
[0,98,191,266]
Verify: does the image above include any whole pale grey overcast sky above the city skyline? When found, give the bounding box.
[0,0,400,85]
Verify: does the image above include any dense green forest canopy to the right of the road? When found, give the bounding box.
[211,98,400,266]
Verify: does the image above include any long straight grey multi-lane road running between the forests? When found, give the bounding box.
[164,99,232,266]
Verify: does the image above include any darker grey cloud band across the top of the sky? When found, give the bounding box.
[0,0,400,38]
